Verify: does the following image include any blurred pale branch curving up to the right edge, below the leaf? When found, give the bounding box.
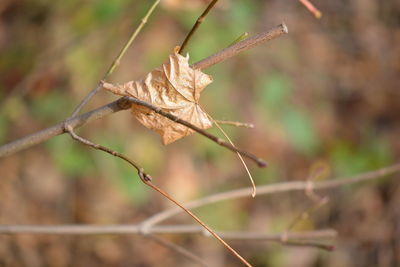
[142,163,400,228]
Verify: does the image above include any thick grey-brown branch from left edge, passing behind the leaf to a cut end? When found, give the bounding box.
[0,24,287,158]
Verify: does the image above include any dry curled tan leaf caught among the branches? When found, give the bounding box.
[103,47,213,144]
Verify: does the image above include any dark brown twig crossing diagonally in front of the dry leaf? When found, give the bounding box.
[126,96,267,167]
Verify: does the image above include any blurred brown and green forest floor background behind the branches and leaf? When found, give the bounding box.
[0,0,400,266]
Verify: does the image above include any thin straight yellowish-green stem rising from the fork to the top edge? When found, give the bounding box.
[67,0,160,118]
